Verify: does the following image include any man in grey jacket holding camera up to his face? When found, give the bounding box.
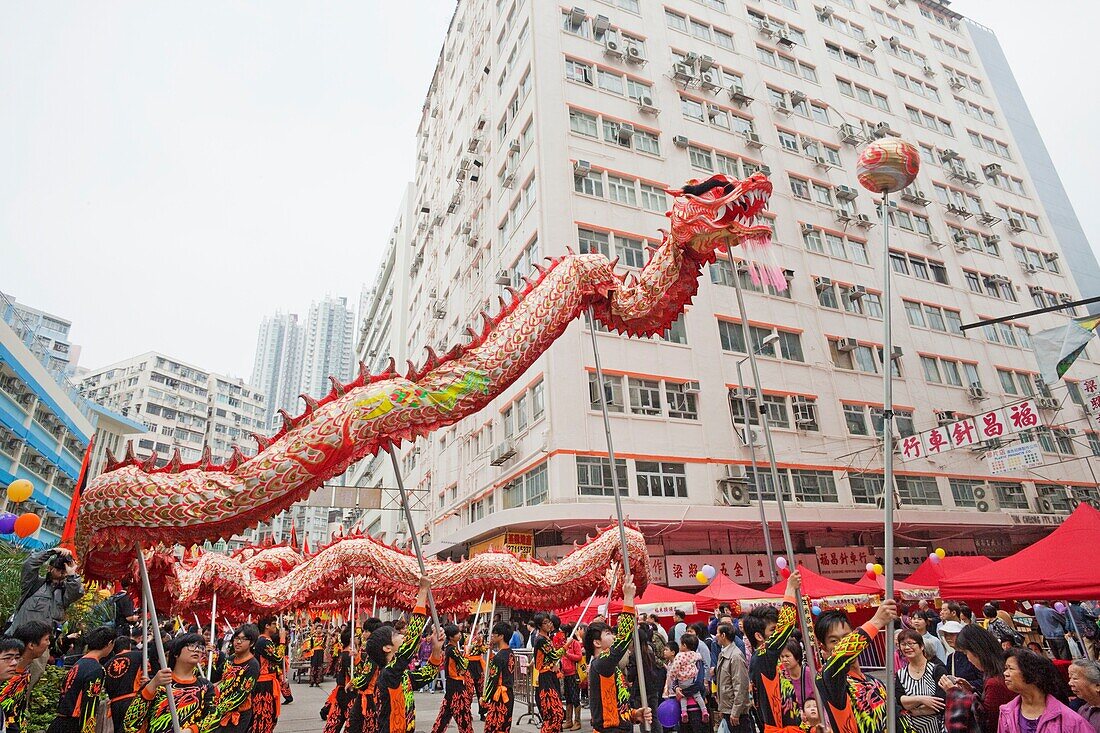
[9,549,84,687]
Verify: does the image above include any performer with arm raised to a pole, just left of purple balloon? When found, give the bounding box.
[584,579,653,733]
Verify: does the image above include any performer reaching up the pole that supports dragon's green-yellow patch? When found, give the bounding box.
[365,577,443,733]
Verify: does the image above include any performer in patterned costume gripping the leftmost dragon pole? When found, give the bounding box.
[123,633,217,733]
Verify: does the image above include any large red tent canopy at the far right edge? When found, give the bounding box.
[939,504,1100,601]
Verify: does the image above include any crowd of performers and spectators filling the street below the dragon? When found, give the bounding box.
[0,550,1100,733]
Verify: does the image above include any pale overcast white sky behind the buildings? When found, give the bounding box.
[0,0,1100,378]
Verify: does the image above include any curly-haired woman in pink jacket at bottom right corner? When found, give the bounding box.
[997,648,1093,733]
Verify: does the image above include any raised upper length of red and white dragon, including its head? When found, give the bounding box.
[76,174,774,580]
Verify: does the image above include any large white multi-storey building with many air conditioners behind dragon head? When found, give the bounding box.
[358,0,1100,584]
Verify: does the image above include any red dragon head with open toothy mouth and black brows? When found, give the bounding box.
[668,173,771,253]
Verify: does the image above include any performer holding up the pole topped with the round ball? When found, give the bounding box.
[814,599,898,733]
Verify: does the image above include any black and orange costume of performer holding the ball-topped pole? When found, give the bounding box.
[817,622,887,733]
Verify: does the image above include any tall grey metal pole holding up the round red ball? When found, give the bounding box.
[882,192,898,733]
